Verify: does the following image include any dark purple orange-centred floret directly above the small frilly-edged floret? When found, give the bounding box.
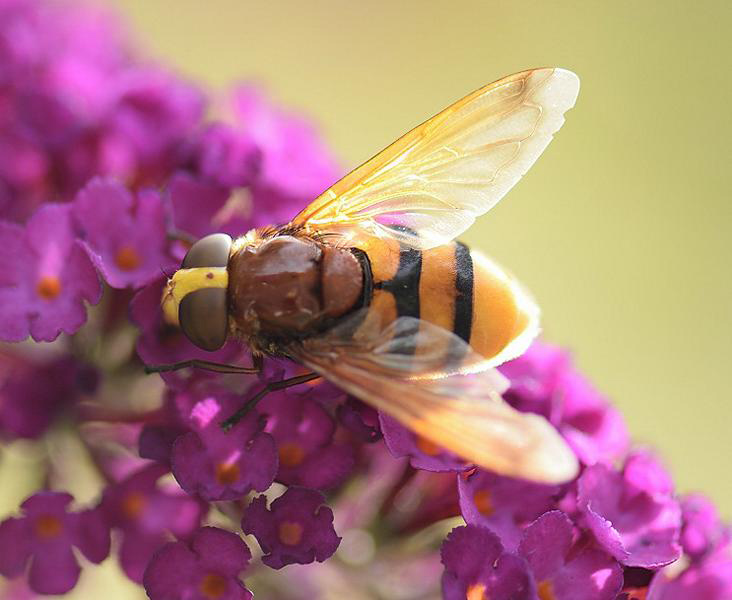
[259,392,354,489]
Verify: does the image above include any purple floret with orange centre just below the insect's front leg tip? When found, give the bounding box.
[171,386,277,500]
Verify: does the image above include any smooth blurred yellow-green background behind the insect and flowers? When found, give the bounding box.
[1,0,732,598]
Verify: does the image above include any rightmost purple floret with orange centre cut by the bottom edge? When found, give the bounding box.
[518,510,623,600]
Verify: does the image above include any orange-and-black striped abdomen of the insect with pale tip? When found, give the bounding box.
[354,238,538,364]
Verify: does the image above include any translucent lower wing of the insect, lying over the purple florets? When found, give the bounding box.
[291,317,578,483]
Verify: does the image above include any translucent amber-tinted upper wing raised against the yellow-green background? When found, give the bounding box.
[293,69,579,250]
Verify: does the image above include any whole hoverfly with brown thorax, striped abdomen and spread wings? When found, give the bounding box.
[157,68,579,483]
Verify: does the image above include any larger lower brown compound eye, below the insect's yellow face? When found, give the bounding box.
[178,288,229,352]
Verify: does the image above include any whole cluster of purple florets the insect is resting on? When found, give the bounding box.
[0,0,732,600]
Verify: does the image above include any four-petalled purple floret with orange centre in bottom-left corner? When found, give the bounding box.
[0,492,110,594]
